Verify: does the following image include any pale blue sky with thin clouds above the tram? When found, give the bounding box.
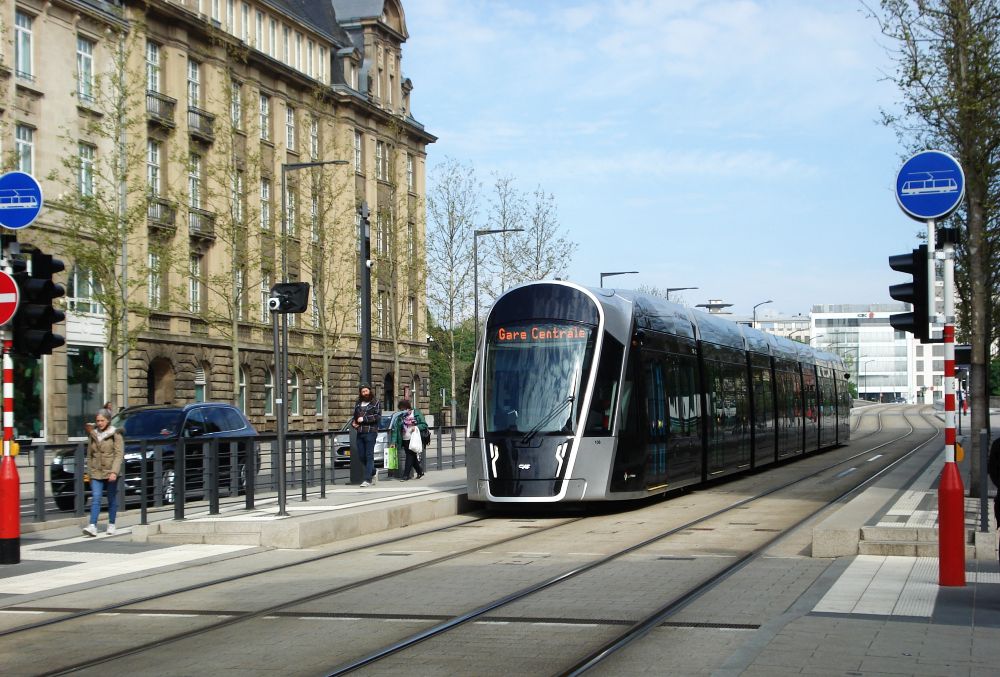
[403,0,925,317]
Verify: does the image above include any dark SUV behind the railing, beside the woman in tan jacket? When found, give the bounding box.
[50,402,260,510]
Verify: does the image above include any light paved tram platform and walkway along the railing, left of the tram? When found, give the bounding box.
[0,467,466,606]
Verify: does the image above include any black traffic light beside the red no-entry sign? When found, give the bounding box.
[13,250,66,358]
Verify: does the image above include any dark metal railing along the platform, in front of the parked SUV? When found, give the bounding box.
[17,427,465,524]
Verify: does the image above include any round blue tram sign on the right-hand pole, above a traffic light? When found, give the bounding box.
[896,150,965,221]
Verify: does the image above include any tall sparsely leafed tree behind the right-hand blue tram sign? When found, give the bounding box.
[871,0,1000,496]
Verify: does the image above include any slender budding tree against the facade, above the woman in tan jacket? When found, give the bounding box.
[48,23,156,404]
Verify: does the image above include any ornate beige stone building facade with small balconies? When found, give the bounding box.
[0,0,435,442]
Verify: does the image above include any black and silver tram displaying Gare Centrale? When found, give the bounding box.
[466,281,851,503]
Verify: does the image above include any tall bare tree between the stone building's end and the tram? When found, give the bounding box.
[427,158,481,423]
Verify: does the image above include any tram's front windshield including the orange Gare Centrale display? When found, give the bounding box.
[483,320,595,437]
